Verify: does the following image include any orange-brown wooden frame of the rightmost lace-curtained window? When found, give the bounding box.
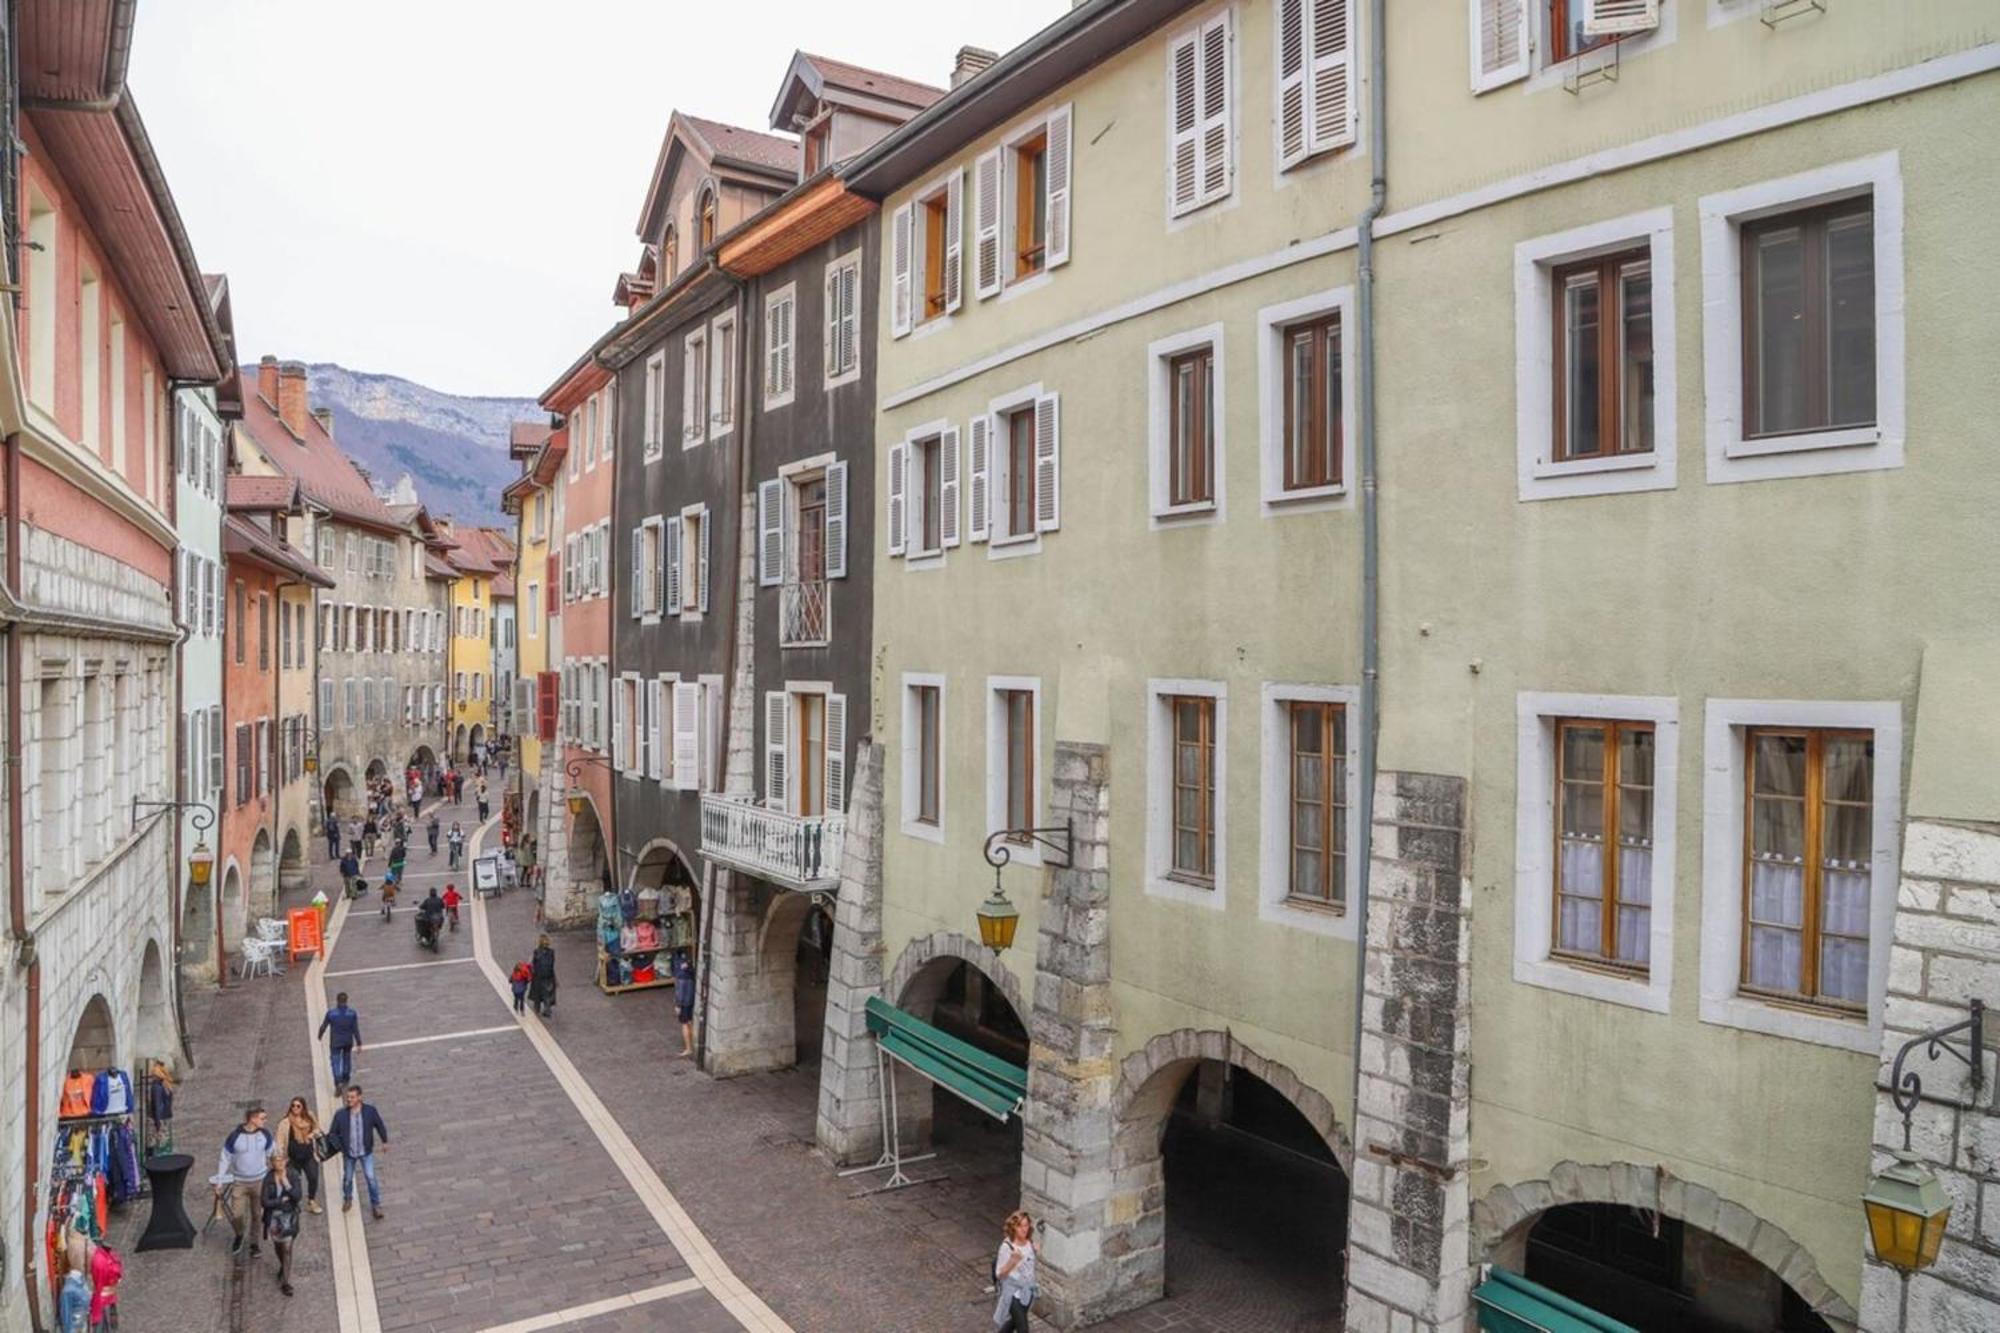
[1736,727,1878,1017]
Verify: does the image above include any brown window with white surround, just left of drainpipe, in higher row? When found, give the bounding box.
[1258,288,1352,512]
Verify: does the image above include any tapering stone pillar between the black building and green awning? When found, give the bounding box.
[816,739,884,1167]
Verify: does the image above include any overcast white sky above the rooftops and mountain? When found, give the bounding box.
[130,0,1068,396]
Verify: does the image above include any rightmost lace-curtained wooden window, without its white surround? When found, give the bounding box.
[1742,727,1874,1009]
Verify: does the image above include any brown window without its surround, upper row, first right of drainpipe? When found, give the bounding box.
[1550,250,1654,462]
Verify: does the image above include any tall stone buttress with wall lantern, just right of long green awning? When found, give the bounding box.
[1020,741,1120,1327]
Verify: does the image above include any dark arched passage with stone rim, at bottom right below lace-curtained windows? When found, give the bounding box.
[1472,1161,1856,1333]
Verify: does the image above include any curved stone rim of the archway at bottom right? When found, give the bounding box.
[1472,1161,1856,1329]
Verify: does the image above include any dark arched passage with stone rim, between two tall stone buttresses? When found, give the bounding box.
[1102,1029,1354,1327]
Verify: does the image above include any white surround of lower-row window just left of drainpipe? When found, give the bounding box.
[1256,683,1362,939]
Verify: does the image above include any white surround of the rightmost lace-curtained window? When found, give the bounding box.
[1702,699,1902,1057]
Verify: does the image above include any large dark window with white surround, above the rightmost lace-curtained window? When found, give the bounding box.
[1700,152,1904,482]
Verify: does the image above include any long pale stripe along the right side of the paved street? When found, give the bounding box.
[472,823,792,1333]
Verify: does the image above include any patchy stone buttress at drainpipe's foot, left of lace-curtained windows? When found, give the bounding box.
[1346,773,1474,1333]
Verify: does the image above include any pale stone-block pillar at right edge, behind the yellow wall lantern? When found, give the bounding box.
[1856,816,2000,1333]
